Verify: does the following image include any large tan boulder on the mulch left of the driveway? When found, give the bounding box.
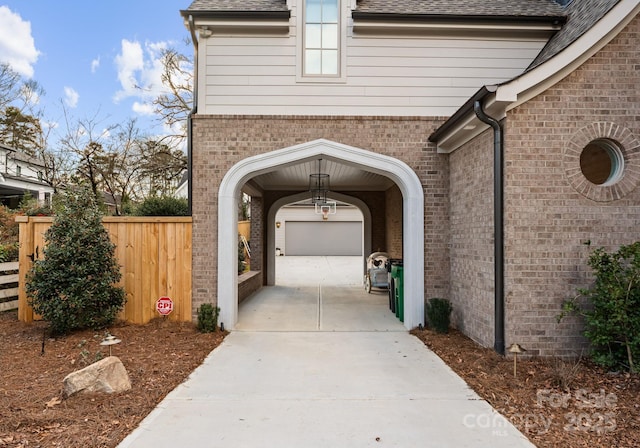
[63,356,131,397]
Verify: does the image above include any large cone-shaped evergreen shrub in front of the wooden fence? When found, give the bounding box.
[26,189,125,334]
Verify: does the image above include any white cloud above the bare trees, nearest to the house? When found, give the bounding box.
[114,39,168,105]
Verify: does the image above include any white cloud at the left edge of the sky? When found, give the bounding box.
[0,6,40,78]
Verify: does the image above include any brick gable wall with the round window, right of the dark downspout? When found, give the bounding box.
[505,14,640,356]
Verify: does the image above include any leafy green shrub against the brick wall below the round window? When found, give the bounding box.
[558,242,640,372]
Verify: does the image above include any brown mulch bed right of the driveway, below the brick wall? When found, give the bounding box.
[412,330,640,448]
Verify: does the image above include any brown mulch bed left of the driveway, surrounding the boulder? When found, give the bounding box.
[0,312,225,448]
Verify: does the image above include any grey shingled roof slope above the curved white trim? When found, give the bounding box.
[527,0,620,70]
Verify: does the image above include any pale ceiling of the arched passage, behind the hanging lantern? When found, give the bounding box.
[250,158,393,191]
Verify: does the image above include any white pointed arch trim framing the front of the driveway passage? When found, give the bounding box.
[218,139,424,330]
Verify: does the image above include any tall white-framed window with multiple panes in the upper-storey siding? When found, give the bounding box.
[303,0,341,77]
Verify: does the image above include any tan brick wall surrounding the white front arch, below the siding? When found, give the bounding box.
[193,116,449,318]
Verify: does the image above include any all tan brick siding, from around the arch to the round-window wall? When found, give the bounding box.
[193,14,640,356]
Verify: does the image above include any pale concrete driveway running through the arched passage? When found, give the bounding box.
[119,257,533,448]
